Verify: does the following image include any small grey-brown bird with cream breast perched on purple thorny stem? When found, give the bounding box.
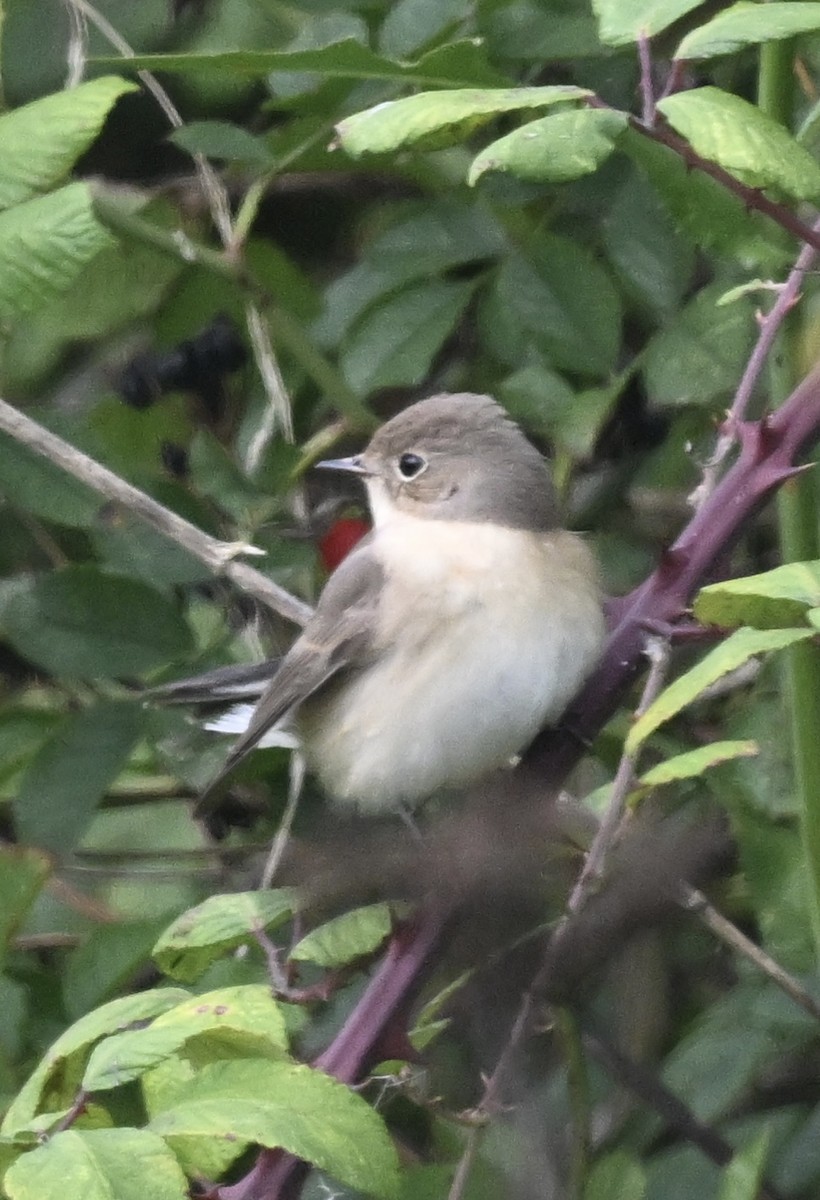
[190,392,604,814]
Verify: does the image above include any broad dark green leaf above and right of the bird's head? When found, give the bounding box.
[481,234,621,378]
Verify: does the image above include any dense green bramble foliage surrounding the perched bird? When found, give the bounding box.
[0,0,820,1200]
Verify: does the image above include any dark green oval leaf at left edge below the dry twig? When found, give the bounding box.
[0,566,193,678]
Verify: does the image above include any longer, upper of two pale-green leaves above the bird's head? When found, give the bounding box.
[336,86,591,158]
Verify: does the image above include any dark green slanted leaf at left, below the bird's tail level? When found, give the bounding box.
[13,701,145,854]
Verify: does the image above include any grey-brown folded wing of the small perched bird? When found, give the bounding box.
[197,538,383,812]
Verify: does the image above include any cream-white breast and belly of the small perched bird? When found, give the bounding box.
[299,518,603,810]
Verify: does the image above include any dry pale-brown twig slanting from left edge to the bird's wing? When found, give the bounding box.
[0,400,311,625]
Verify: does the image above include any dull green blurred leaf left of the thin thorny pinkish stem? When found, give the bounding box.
[644,283,755,408]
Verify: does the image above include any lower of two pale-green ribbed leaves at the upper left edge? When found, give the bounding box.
[0,184,114,320]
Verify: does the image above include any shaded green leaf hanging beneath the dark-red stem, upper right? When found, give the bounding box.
[620,128,790,271]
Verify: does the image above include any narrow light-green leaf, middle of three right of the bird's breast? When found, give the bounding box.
[624,629,814,754]
